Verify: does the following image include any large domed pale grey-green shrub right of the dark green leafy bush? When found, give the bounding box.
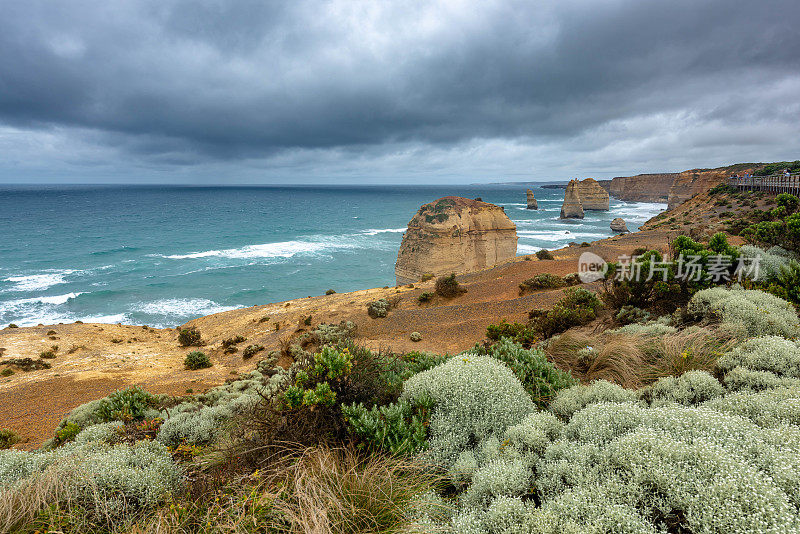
[401,354,535,468]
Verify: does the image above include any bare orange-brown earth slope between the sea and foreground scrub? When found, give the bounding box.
[0,165,763,448]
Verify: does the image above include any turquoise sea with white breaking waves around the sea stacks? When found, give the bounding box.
[0,185,666,327]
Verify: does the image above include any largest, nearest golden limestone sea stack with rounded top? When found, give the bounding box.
[394,197,517,284]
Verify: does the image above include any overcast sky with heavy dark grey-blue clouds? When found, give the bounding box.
[0,0,800,183]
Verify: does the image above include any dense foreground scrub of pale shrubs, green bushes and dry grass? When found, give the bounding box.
[7,238,800,534]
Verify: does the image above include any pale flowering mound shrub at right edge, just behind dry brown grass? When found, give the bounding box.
[687,287,800,338]
